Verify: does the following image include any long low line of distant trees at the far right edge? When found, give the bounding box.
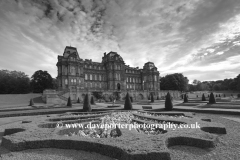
[189,74,240,91]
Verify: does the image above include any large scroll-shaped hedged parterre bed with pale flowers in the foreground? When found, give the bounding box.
[2,112,227,160]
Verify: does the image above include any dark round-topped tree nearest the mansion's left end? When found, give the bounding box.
[31,70,53,93]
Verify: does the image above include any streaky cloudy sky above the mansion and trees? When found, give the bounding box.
[0,0,240,81]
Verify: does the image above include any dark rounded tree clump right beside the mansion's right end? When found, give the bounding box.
[160,73,189,91]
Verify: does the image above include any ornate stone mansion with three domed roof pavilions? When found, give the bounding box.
[57,46,160,100]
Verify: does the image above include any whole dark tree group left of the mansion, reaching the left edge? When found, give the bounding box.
[0,70,57,94]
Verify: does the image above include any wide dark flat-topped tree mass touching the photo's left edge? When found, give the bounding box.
[0,70,30,94]
